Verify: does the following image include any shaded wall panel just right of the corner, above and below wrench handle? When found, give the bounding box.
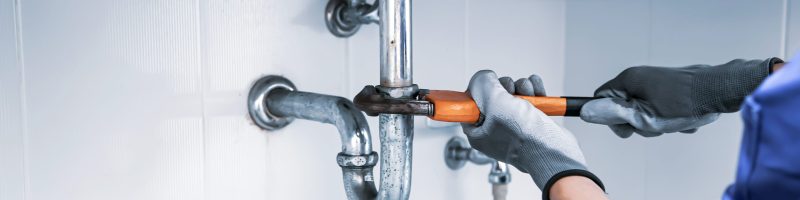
[564,0,650,199]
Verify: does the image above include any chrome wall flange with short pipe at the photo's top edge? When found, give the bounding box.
[325,0,379,38]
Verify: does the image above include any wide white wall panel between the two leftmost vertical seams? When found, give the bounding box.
[22,0,203,199]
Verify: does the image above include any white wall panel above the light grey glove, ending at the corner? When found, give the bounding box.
[465,0,566,95]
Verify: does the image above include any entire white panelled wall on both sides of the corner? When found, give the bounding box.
[0,0,800,200]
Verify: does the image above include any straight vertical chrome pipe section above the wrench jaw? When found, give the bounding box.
[378,0,413,87]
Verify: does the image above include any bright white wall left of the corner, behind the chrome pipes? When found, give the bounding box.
[0,0,565,200]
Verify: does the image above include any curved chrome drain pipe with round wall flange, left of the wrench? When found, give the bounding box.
[248,76,378,199]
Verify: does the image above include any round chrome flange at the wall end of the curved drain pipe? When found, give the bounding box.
[247,75,297,130]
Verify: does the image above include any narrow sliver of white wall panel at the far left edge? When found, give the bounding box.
[0,0,25,200]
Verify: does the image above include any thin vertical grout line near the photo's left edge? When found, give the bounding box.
[13,0,31,199]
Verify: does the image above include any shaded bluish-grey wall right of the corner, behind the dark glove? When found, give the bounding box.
[564,0,800,199]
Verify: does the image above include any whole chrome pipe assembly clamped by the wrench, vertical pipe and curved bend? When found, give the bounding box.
[260,0,419,200]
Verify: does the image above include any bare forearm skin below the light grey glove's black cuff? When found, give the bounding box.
[550,176,608,200]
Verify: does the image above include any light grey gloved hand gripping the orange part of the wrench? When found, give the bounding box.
[462,70,602,193]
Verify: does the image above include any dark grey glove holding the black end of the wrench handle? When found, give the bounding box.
[581,58,782,138]
